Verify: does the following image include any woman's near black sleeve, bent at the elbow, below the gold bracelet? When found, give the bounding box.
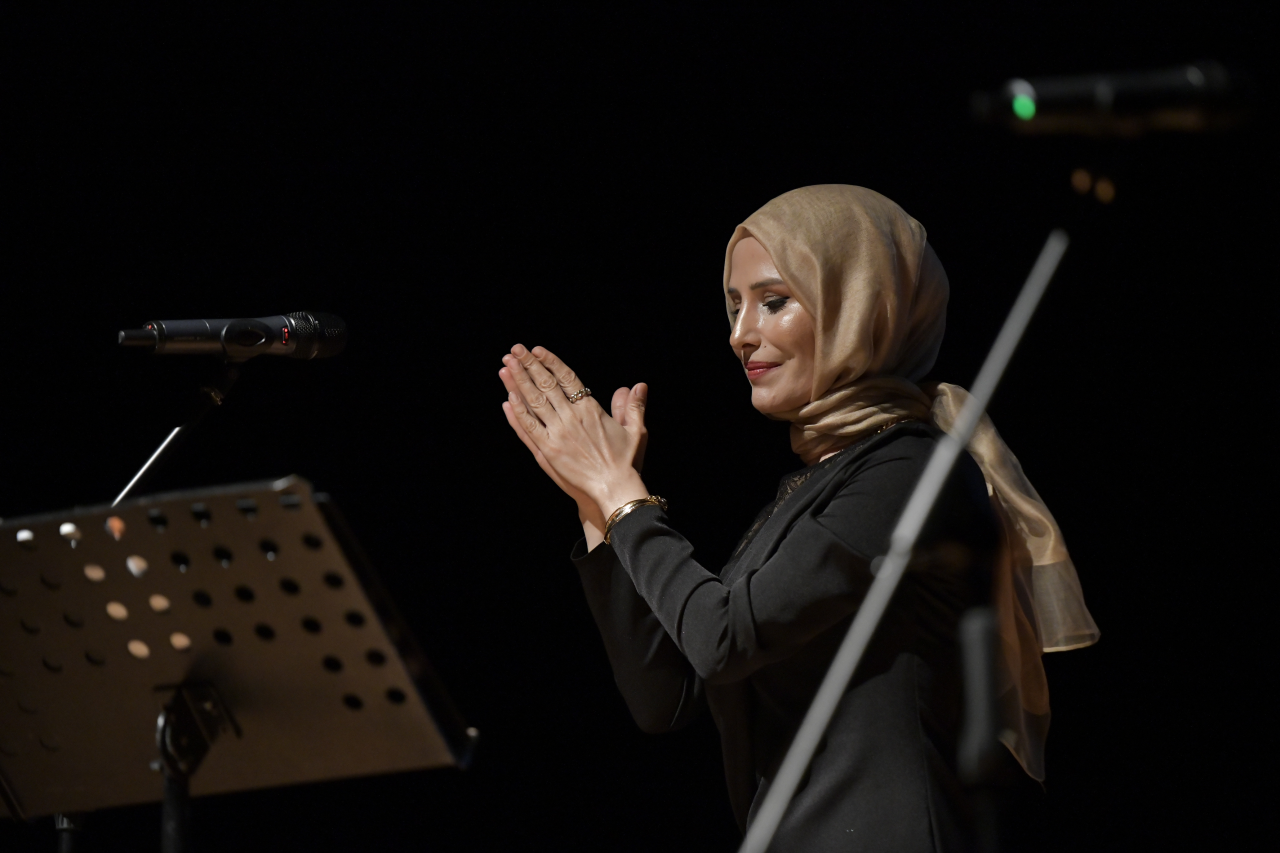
[611,435,986,684]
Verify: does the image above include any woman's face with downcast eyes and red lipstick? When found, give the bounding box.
[728,237,814,414]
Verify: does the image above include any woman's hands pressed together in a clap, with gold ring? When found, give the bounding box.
[498,345,649,519]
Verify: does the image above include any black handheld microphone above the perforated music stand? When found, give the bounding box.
[118,311,347,361]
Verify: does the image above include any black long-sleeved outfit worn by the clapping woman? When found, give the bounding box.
[573,421,1000,853]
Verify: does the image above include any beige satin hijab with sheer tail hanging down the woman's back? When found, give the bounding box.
[724,184,1098,780]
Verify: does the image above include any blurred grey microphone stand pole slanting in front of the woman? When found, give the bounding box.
[739,229,1068,853]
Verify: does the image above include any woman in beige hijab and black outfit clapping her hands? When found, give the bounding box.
[499,186,1097,852]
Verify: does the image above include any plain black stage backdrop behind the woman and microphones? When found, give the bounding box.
[0,3,1276,853]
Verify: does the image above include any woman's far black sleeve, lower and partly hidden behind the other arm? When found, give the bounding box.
[570,539,705,734]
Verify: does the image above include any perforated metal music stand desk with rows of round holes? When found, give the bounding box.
[0,478,475,818]
